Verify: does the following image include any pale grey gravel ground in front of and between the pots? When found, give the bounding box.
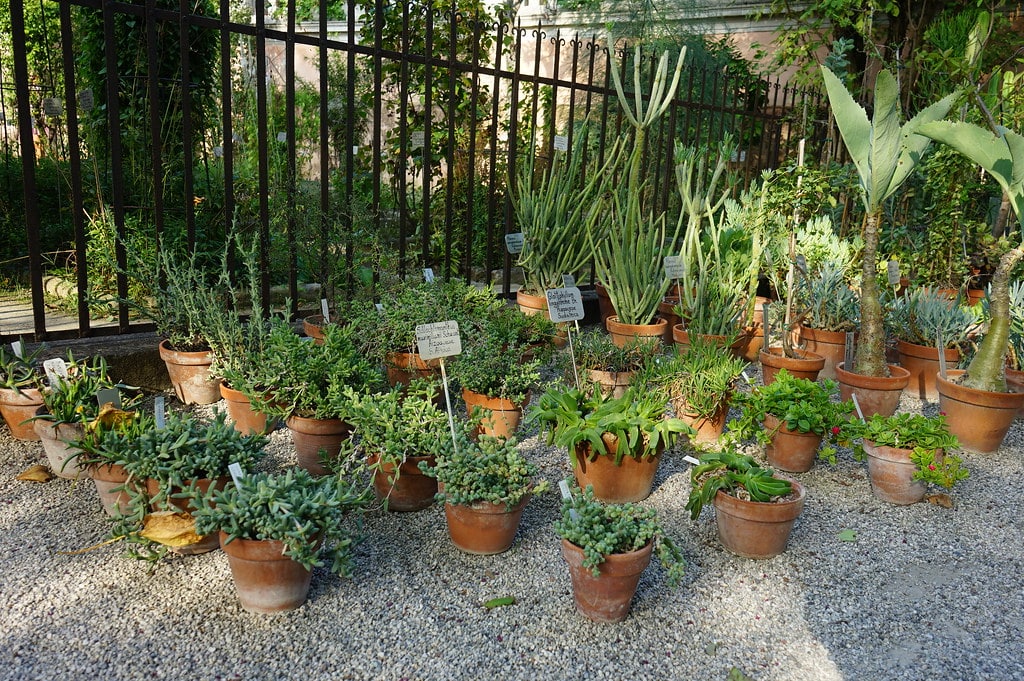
[0,366,1024,681]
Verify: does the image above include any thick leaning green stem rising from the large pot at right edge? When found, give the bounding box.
[964,246,1024,392]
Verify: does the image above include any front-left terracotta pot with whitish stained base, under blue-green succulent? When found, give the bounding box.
[219,533,312,613]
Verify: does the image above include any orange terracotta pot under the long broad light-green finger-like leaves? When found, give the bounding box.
[572,433,662,504]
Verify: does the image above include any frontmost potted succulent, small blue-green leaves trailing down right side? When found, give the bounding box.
[555,486,686,623]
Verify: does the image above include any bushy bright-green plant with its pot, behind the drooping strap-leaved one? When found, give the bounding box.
[729,369,853,473]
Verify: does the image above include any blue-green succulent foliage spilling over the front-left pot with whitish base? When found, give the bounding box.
[193,469,370,576]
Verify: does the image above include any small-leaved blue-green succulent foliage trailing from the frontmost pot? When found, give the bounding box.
[555,485,686,585]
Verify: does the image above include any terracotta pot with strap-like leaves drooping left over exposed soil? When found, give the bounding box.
[686,449,806,559]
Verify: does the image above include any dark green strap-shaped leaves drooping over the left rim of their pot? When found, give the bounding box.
[686,450,793,520]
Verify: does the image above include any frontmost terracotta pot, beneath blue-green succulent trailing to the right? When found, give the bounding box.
[562,539,654,623]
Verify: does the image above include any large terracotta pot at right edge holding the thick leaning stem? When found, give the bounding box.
[935,370,1024,454]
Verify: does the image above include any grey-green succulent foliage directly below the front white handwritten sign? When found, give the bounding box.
[420,434,549,508]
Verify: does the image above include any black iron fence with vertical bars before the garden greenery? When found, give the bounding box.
[0,0,827,340]
